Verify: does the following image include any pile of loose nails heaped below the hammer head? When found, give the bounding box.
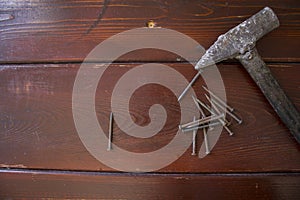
[179,86,242,155]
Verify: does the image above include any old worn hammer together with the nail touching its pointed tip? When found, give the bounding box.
[178,7,300,143]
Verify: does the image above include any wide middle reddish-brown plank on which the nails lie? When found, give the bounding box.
[0,64,300,172]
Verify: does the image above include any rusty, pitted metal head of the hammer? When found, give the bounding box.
[195,7,279,70]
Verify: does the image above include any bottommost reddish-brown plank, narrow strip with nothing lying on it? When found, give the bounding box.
[0,170,300,200]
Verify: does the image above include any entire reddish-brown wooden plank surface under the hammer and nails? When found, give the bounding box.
[0,0,300,199]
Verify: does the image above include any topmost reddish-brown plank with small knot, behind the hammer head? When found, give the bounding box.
[0,0,300,63]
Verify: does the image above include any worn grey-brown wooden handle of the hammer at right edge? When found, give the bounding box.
[237,48,300,143]
